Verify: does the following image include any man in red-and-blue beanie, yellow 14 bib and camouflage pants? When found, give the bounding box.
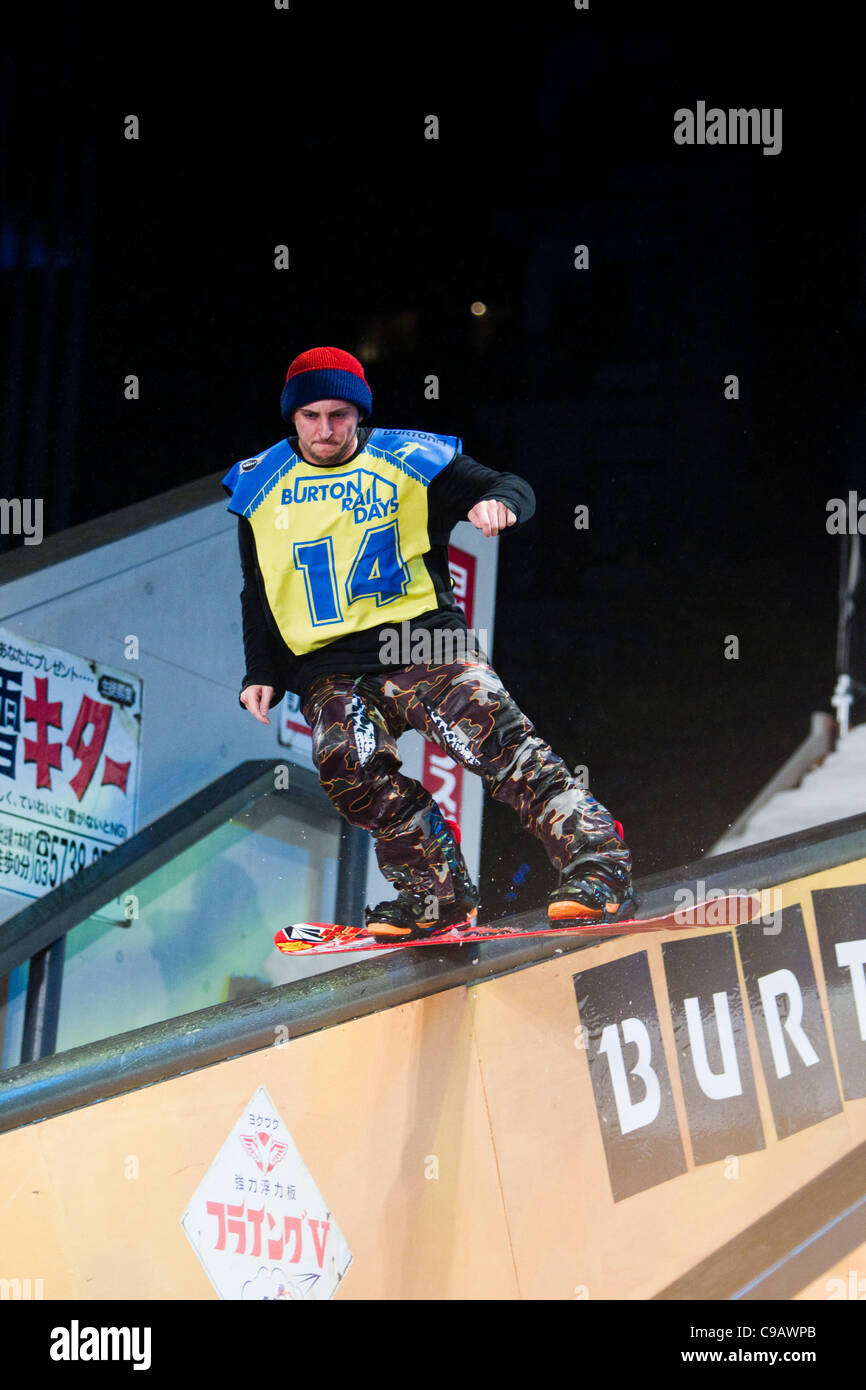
[222,348,631,941]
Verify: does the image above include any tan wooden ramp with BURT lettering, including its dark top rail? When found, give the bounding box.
[0,817,866,1300]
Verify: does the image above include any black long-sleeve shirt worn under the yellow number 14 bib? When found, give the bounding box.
[238,428,535,709]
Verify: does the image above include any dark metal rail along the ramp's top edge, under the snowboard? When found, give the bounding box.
[0,806,866,1133]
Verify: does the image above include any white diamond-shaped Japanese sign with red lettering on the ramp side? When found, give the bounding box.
[181,1086,352,1300]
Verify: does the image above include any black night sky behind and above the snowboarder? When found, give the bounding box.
[1,0,866,909]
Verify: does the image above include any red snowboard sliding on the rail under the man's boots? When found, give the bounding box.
[274,892,760,955]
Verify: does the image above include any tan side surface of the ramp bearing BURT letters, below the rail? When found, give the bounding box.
[0,860,866,1300]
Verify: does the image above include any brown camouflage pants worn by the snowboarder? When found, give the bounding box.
[302,660,631,902]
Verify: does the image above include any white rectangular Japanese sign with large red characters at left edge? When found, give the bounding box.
[0,628,142,898]
